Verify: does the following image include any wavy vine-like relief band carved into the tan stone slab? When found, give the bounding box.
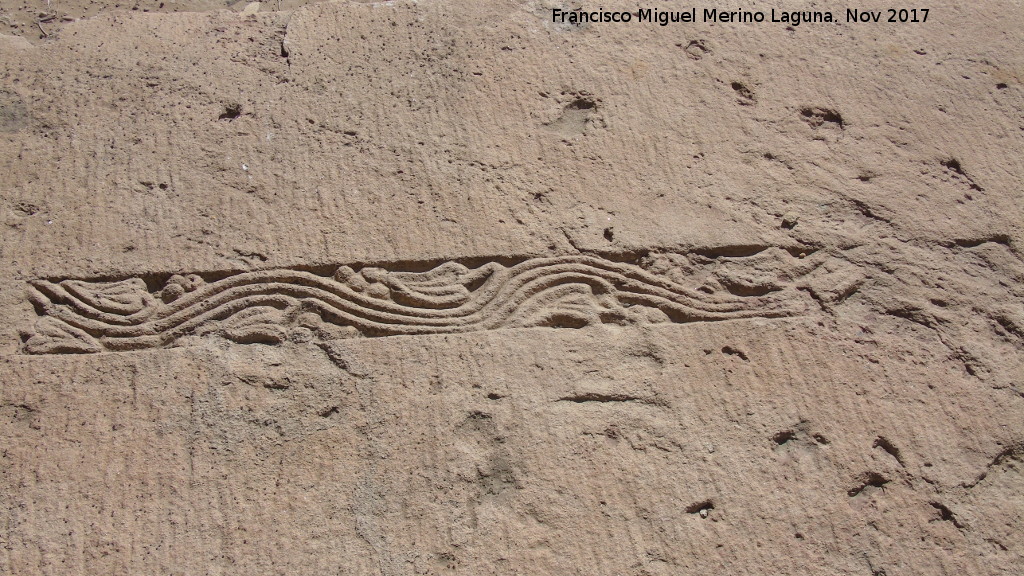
[23,255,823,354]
